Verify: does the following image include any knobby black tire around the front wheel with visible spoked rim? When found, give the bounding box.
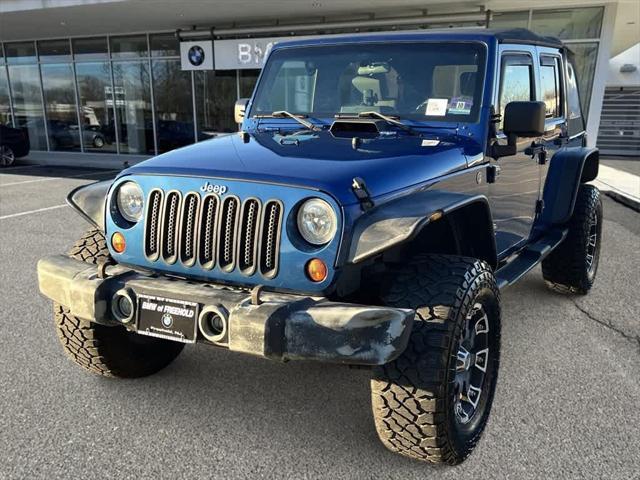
[371,255,500,465]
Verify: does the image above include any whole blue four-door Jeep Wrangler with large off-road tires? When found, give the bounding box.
[38,30,602,464]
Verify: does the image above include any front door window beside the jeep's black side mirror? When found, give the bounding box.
[498,55,535,130]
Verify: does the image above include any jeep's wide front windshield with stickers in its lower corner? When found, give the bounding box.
[251,42,485,122]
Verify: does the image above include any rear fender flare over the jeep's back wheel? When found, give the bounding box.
[541,147,600,225]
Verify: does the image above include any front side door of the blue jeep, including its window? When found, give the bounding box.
[489,46,540,256]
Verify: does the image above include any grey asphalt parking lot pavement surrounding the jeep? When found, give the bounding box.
[0,166,640,480]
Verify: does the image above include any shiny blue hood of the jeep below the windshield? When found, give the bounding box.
[123,131,478,205]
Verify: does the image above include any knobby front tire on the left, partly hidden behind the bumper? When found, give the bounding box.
[53,229,184,378]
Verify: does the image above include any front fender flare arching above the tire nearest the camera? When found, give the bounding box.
[346,190,497,268]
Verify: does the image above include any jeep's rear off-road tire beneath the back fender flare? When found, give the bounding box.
[542,185,602,295]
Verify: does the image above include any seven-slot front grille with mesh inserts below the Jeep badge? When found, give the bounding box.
[144,189,284,278]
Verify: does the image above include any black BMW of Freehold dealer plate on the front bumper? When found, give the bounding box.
[138,294,199,343]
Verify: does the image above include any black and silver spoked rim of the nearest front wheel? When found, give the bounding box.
[453,303,489,425]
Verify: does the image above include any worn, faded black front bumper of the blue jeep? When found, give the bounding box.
[38,255,415,365]
